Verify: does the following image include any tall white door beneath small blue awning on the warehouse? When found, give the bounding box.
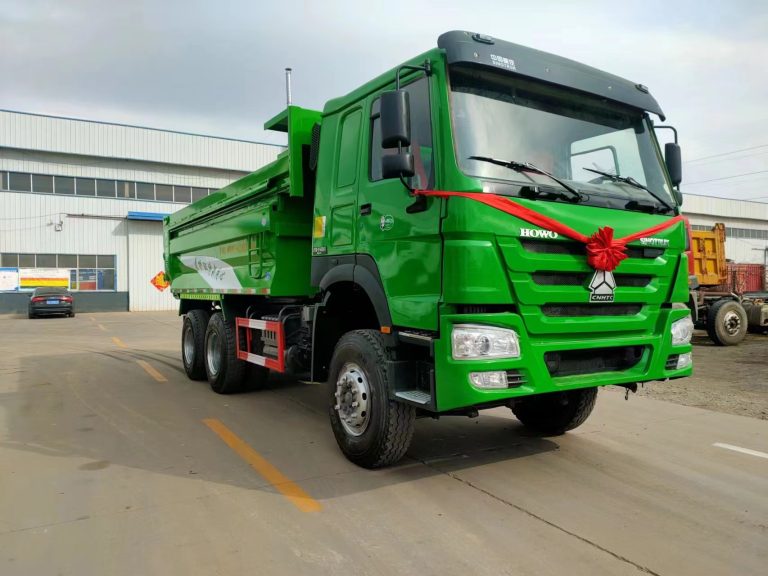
[128,220,178,312]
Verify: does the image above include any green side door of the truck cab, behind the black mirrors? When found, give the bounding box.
[356,77,442,330]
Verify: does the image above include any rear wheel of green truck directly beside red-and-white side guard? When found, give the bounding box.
[204,312,247,394]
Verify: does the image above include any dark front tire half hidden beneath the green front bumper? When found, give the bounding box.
[512,388,597,436]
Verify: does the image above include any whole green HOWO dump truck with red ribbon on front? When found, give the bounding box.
[164,31,692,468]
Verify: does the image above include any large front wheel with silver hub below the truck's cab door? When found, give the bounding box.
[328,330,416,468]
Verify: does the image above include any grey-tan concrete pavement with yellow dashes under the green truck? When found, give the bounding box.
[0,313,768,576]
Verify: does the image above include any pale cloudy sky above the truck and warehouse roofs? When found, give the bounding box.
[0,0,768,201]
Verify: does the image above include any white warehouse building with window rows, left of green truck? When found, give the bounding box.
[0,110,284,314]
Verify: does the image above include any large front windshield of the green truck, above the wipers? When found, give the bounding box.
[451,66,674,211]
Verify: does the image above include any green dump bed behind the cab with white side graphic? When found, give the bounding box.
[163,106,320,298]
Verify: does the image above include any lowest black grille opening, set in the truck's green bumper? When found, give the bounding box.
[544,346,645,376]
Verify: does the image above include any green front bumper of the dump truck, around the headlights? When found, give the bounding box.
[434,308,692,412]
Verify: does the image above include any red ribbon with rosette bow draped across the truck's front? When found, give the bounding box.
[414,190,683,272]
